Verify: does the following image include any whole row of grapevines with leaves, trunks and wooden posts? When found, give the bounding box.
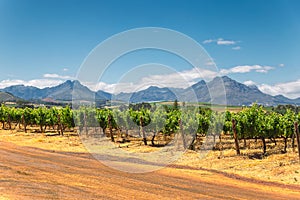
[0,102,300,158]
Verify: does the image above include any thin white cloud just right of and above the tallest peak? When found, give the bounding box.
[220,65,274,75]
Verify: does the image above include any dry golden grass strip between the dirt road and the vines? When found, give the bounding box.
[0,130,300,185]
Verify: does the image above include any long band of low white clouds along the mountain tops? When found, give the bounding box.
[0,65,300,98]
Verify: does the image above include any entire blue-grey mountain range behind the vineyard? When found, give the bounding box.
[0,76,300,106]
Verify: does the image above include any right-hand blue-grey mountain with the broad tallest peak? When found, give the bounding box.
[115,76,300,106]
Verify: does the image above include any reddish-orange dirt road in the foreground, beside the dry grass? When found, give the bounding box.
[0,142,300,200]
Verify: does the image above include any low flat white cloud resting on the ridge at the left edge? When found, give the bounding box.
[0,79,63,88]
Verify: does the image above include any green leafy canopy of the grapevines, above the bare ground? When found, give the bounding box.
[0,101,300,154]
